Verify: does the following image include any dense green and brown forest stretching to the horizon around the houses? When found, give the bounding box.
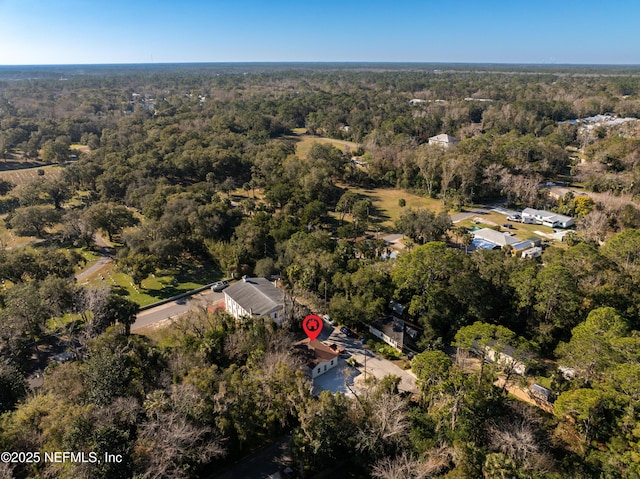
[0,64,640,479]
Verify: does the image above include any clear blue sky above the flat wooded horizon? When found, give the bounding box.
[0,0,640,65]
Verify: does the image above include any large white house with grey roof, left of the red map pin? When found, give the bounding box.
[224,276,284,324]
